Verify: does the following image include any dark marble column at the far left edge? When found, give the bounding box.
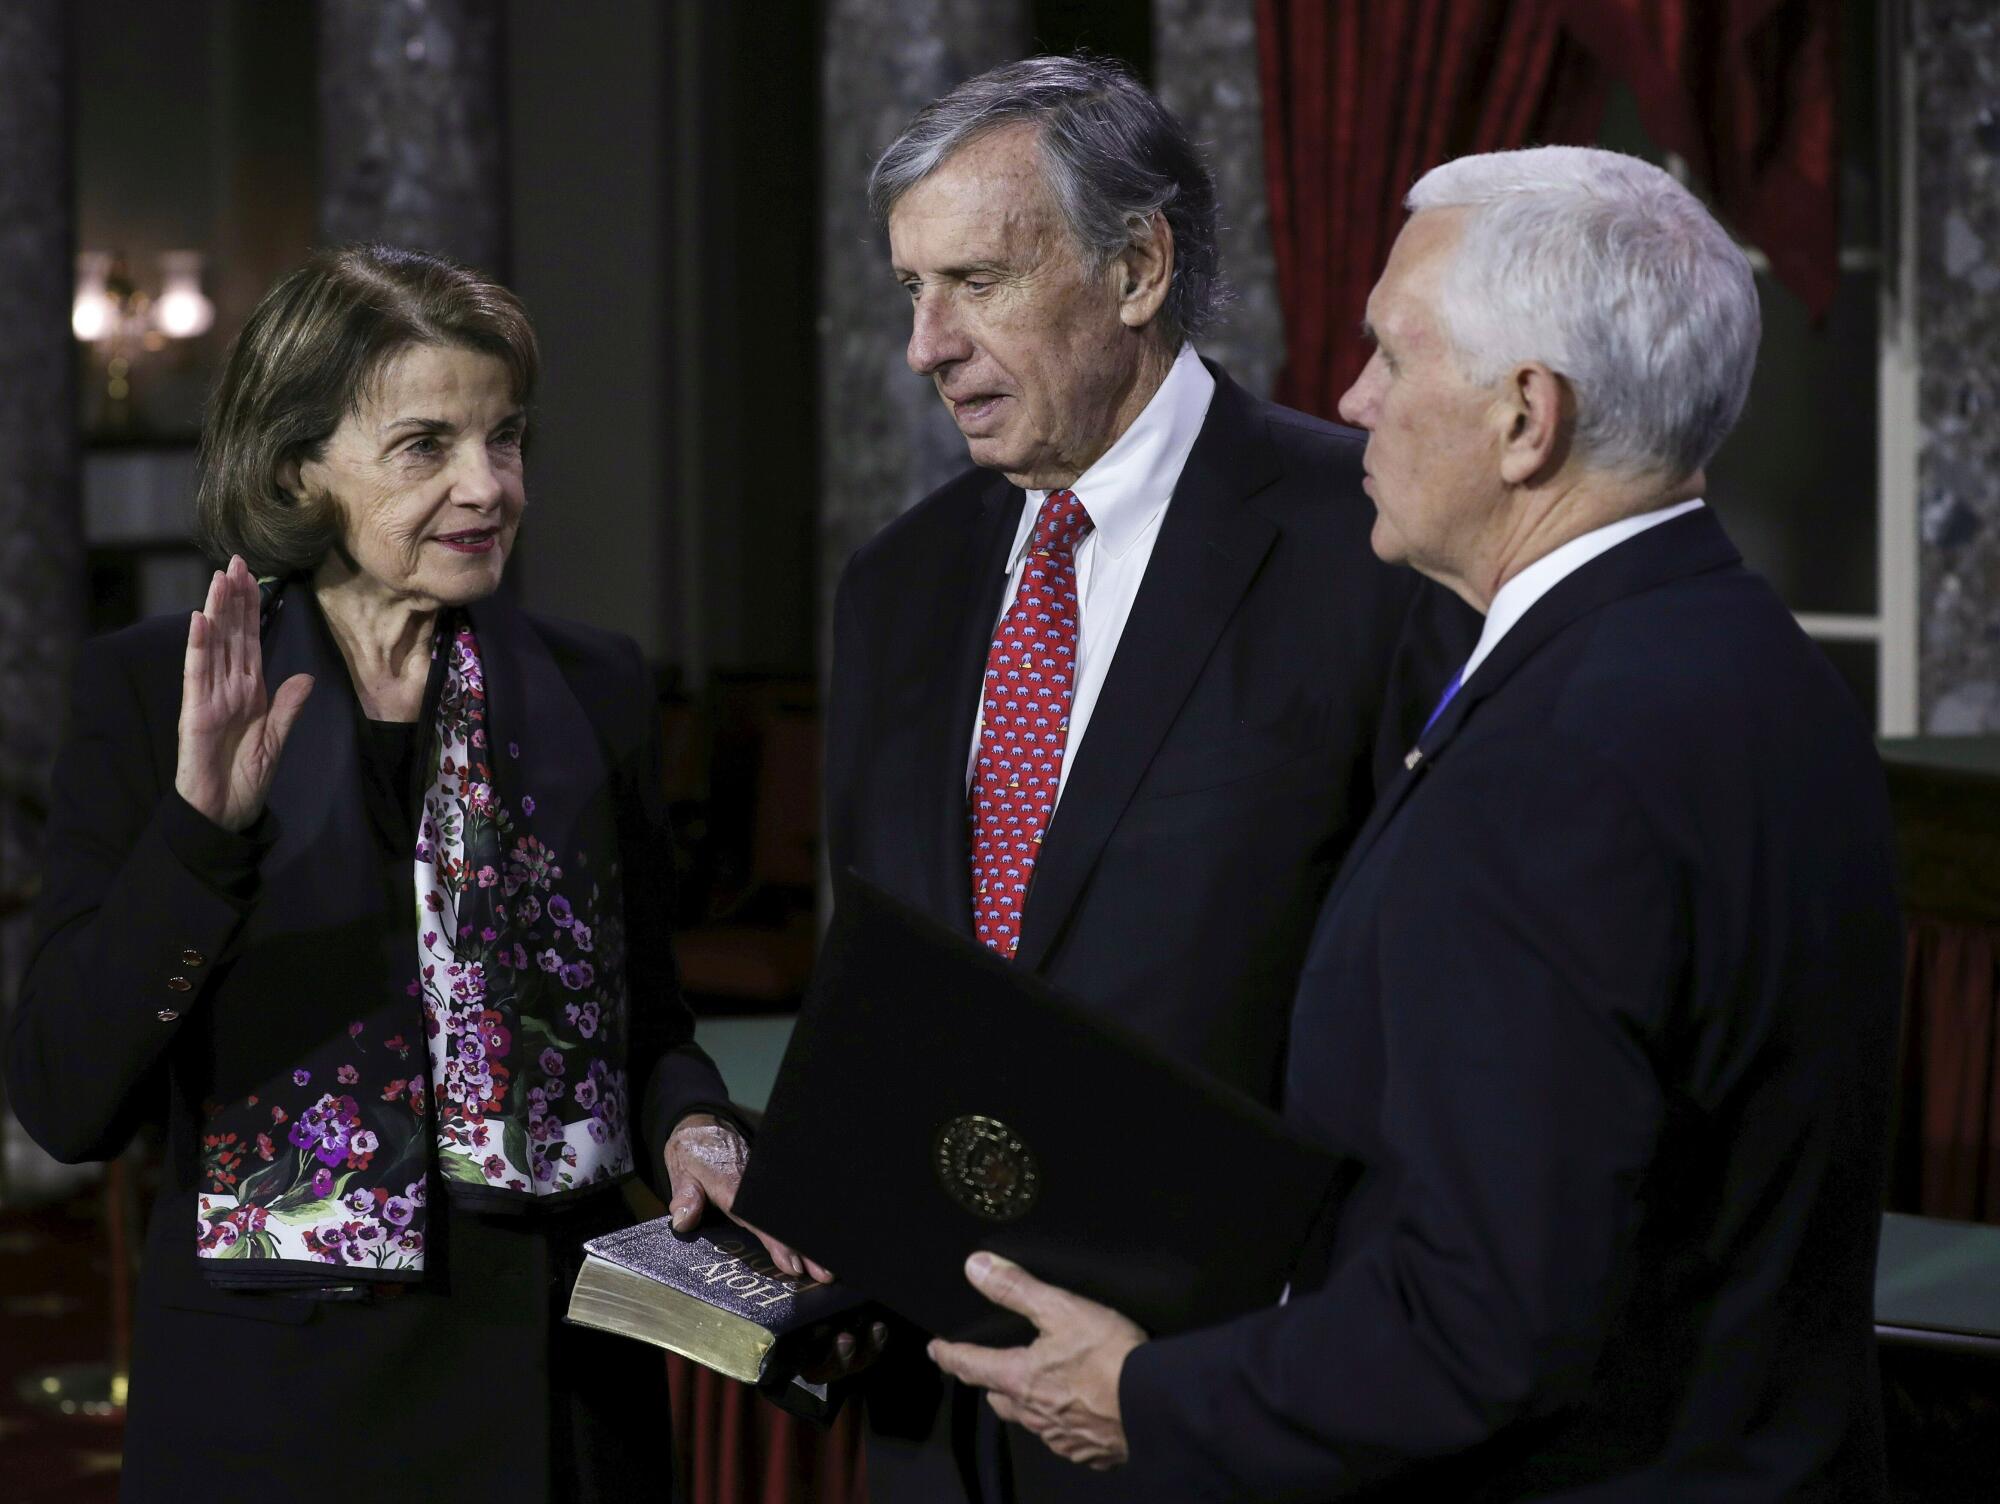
[0,0,84,1184]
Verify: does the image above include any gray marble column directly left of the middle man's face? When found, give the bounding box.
[818,0,1030,660]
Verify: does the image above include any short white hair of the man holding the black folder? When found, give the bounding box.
[1404,146,1762,478]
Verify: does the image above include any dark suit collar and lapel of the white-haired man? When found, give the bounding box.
[1326,506,1742,912]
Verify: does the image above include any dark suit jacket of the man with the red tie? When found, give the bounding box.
[826,372,1476,1498]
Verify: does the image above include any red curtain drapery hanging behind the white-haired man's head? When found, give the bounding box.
[1258,0,1838,416]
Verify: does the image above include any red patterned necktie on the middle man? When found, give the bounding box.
[968,490,1090,960]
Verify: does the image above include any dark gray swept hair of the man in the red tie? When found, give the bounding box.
[868,58,1228,350]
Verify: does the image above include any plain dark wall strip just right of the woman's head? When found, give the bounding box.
[506,0,680,656]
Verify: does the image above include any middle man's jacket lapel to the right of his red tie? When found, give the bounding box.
[1016,372,1278,966]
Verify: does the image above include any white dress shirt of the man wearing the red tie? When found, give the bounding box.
[966,344,1216,802]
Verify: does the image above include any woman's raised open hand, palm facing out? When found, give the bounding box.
[174,558,312,830]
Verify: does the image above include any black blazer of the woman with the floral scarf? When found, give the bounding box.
[6,586,726,1308]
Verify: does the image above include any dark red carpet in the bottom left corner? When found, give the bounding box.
[0,1190,122,1504]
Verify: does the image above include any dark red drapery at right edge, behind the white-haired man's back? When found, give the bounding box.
[1890,914,2000,1222]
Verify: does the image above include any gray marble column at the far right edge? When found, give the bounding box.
[1910,0,2000,734]
